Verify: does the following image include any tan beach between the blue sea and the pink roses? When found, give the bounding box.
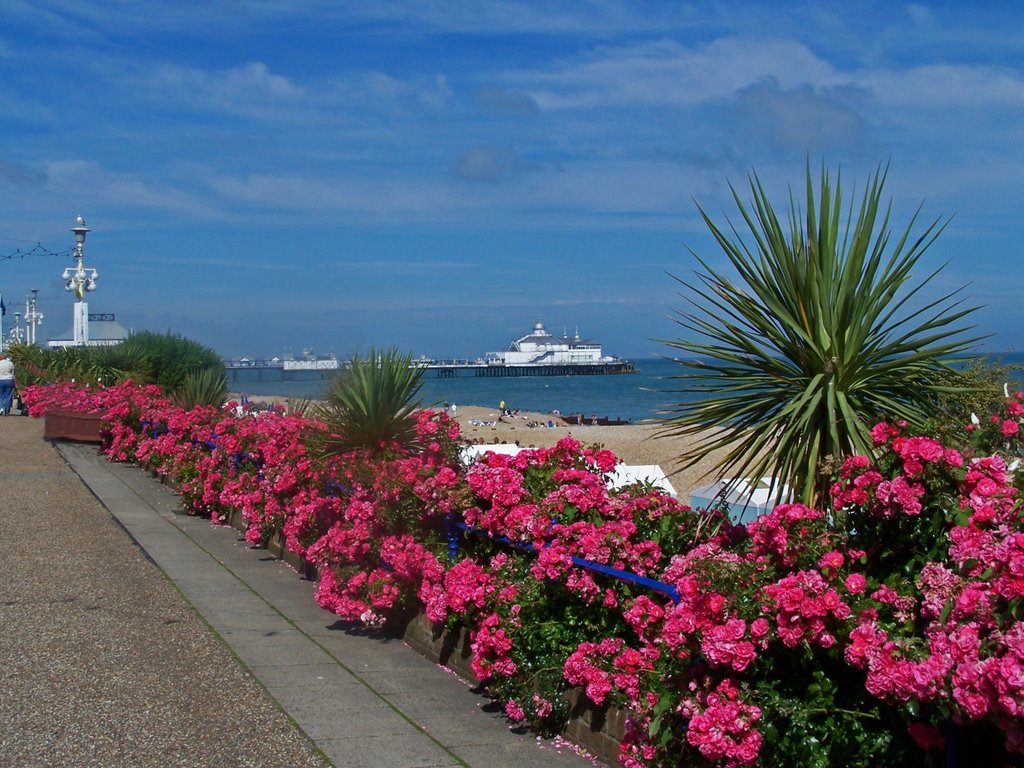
[228,392,724,503]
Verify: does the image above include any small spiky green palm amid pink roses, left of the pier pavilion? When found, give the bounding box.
[314,347,423,456]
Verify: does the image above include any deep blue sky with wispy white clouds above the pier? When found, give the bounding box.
[0,0,1024,357]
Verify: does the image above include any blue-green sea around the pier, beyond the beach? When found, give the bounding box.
[228,352,1024,423]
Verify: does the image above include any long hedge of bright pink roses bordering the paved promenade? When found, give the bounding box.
[24,383,1024,768]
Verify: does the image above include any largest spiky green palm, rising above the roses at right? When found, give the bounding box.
[663,165,979,504]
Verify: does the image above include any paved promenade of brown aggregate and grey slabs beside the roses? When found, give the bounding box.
[0,417,592,768]
